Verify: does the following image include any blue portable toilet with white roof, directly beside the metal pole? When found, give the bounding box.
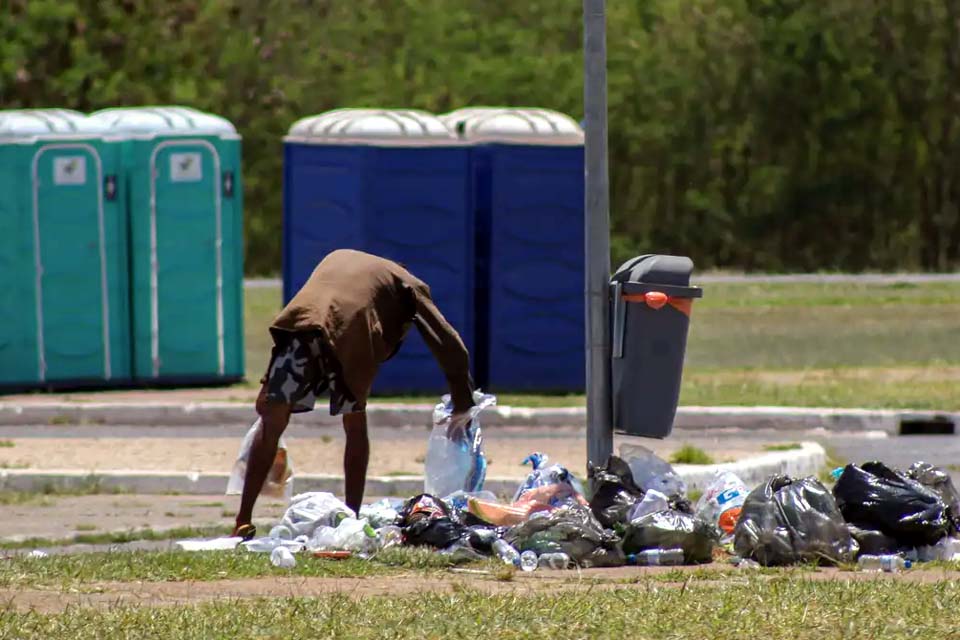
[442,108,585,392]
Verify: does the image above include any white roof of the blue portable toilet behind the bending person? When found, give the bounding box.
[284,109,458,146]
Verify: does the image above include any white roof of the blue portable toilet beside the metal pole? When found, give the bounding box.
[441,107,583,146]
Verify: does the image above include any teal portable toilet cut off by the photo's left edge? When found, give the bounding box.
[0,109,131,388]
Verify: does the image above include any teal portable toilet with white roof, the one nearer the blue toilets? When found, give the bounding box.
[91,107,243,383]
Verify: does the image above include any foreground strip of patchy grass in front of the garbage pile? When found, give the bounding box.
[0,553,960,640]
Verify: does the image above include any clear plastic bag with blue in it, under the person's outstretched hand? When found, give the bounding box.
[423,391,497,497]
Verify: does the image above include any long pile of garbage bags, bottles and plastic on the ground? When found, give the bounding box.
[181,393,960,571]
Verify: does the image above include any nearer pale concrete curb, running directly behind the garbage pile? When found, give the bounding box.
[0,442,827,498]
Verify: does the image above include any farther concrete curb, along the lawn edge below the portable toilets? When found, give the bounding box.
[0,402,960,434]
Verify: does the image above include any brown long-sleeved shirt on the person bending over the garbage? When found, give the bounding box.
[271,249,473,411]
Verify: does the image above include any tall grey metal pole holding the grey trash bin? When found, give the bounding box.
[583,0,613,464]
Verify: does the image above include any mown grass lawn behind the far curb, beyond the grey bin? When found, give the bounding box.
[245,282,960,410]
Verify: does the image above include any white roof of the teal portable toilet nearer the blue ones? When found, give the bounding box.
[90,107,237,137]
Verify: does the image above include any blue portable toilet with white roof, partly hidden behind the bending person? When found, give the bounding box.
[283,109,474,395]
